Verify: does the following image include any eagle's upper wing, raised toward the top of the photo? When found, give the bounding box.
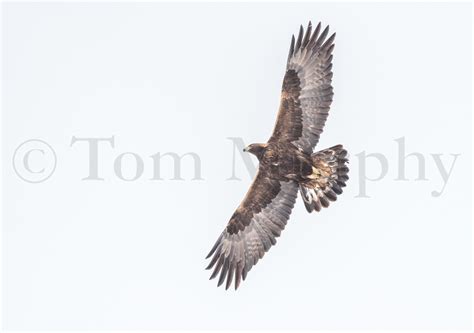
[269,22,336,153]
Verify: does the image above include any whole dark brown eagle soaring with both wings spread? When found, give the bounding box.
[206,22,349,289]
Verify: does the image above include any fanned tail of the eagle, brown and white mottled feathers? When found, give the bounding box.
[300,145,349,213]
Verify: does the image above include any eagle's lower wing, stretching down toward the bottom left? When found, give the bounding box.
[206,171,298,289]
